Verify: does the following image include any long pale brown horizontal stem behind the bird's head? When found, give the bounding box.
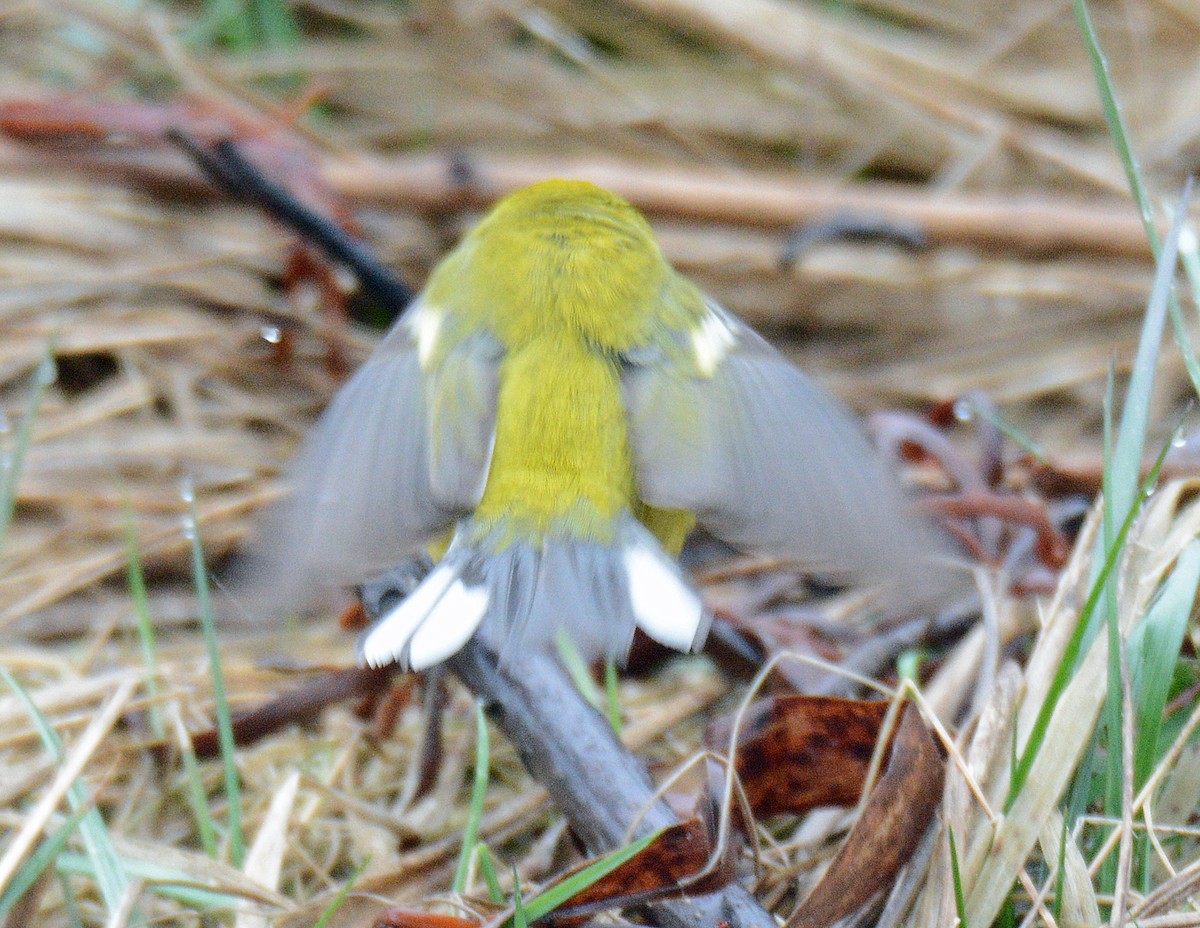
[322,155,1150,257]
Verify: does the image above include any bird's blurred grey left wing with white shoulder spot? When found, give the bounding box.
[256,304,500,607]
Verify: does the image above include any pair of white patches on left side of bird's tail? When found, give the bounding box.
[359,564,490,670]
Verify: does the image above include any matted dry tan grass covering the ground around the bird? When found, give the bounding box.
[0,0,1200,928]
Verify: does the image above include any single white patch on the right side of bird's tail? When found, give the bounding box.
[624,541,707,651]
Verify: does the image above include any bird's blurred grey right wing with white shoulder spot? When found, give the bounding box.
[624,295,949,605]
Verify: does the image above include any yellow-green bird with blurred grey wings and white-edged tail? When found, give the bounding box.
[260,180,943,670]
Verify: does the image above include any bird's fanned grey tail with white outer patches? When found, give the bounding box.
[360,516,710,670]
